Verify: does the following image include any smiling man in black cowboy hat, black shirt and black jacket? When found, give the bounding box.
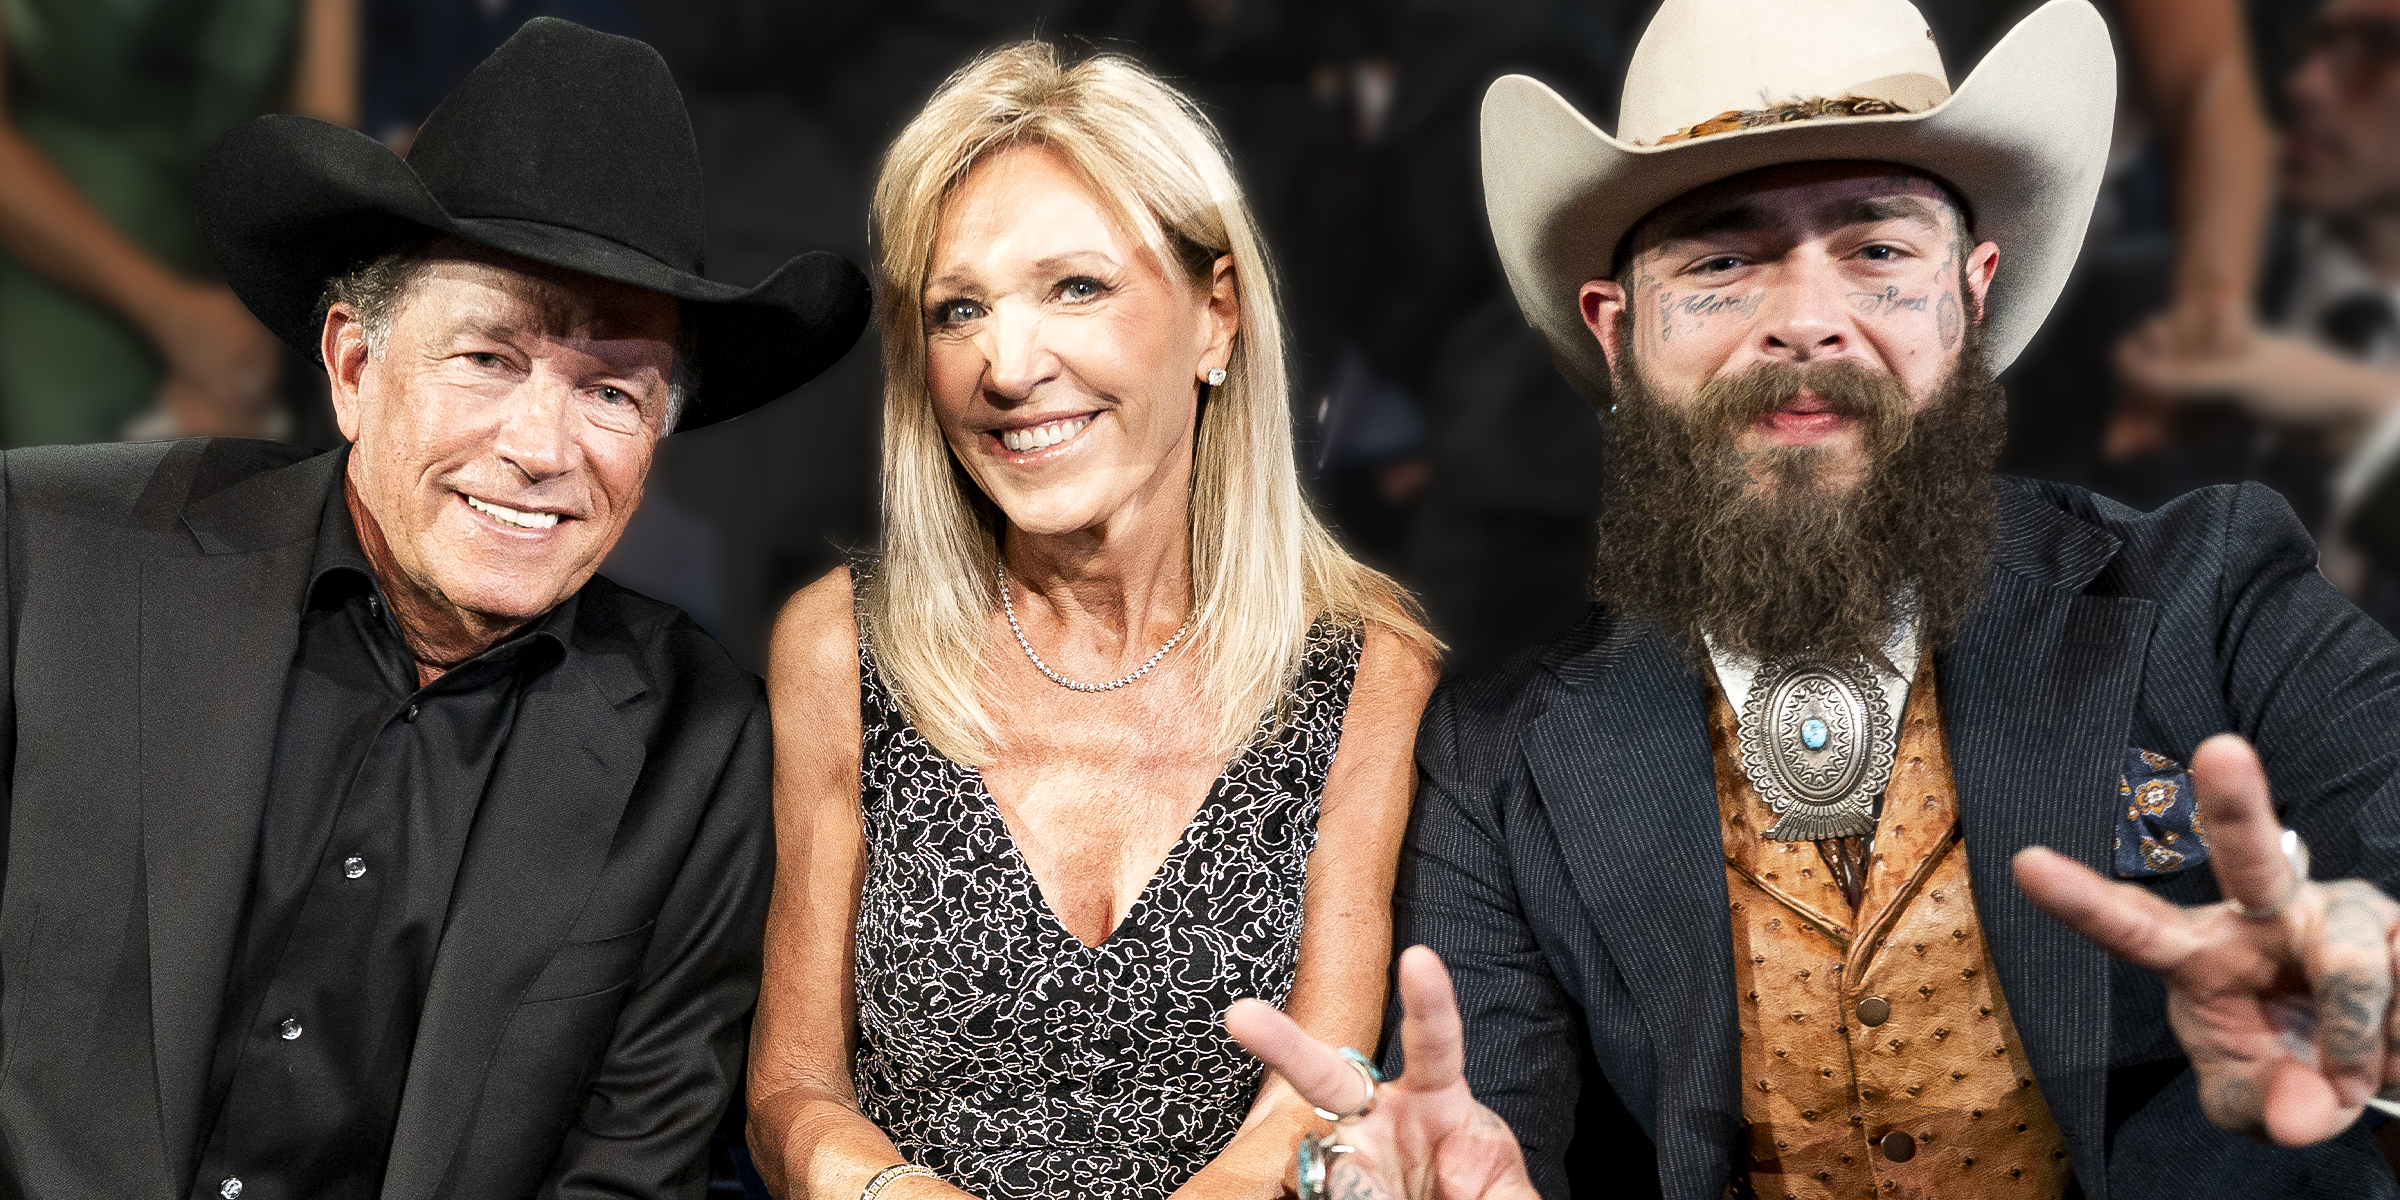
[0,22,866,1200]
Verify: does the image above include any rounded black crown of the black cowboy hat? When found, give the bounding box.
[408,17,708,274]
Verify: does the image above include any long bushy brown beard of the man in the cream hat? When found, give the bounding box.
[1594,338,2006,672]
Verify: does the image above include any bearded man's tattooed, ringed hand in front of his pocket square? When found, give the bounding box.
[2016,734,2400,1145]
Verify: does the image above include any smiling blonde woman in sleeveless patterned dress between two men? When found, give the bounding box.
[751,43,1435,1200]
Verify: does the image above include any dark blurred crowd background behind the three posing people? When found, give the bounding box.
[14,0,2400,1188]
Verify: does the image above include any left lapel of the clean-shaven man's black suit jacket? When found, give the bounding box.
[142,538,314,1174]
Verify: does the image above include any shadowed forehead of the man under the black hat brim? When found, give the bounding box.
[403,238,682,350]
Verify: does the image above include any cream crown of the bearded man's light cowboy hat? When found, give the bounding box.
[1618,0,1951,146]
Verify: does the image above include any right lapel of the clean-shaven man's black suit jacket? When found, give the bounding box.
[384,653,643,1200]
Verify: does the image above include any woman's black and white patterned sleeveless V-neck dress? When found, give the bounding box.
[854,622,1358,1200]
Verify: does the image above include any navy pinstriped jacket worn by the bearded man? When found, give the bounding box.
[1397,480,2400,1200]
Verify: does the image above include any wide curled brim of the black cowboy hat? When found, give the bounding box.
[197,115,869,432]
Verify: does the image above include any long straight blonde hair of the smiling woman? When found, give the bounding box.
[859,41,1438,763]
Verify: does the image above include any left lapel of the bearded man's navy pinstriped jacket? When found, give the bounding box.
[1524,624,1740,1198]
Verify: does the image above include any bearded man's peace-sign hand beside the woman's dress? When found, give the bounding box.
[1224,946,1538,1200]
